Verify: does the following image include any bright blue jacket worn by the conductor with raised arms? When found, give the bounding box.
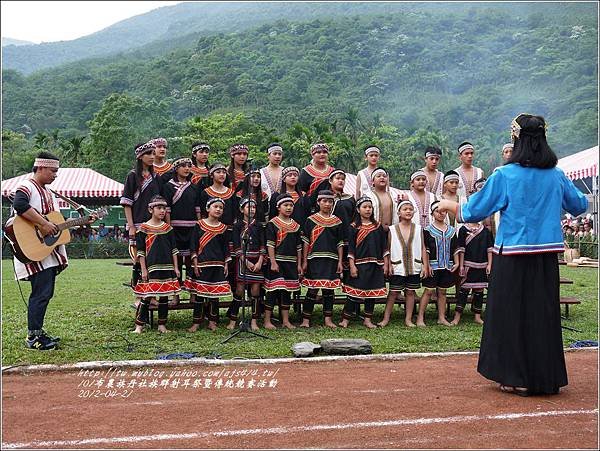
[457,163,587,255]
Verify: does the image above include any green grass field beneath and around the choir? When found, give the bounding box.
[2,260,598,366]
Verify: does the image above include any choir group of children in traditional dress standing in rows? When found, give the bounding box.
[120,138,496,332]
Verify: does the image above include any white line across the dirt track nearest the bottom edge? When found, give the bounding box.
[2,409,598,449]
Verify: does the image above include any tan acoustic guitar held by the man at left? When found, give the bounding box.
[4,207,107,264]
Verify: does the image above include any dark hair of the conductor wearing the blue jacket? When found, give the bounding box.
[507,114,558,169]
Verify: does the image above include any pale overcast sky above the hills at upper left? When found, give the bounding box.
[0,1,181,44]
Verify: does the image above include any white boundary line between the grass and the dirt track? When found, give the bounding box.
[2,347,598,375]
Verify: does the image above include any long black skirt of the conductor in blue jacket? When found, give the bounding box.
[477,253,568,394]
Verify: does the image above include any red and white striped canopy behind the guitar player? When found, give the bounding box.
[2,168,123,197]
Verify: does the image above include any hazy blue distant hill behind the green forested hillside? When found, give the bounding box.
[2,2,592,74]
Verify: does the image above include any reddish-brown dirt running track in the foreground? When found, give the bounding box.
[2,349,598,449]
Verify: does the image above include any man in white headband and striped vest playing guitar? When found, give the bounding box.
[13,152,96,350]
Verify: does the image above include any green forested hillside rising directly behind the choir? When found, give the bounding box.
[3,4,598,185]
